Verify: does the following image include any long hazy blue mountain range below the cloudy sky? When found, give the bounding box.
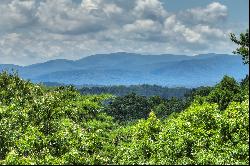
[0,52,249,87]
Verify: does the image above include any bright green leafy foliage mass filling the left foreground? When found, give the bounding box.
[0,72,115,164]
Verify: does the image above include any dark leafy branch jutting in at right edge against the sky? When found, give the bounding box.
[230,29,249,64]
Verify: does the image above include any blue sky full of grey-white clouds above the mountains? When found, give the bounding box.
[0,0,249,65]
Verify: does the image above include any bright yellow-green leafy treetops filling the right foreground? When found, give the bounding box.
[114,100,249,165]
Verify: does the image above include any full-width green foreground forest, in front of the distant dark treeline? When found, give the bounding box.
[0,30,249,165]
